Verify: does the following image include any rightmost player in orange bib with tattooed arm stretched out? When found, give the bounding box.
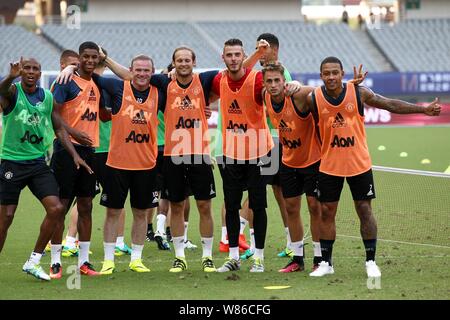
[307,57,441,277]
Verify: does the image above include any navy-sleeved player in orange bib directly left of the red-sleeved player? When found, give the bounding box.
[151,46,217,272]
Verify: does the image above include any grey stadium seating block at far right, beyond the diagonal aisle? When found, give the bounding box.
[369,19,450,71]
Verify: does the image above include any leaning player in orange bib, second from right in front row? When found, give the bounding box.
[262,62,321,272]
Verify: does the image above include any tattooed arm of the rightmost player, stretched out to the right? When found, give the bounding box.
[359,87,441,116]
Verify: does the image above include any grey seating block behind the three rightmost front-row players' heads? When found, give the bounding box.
[199,21,379,73]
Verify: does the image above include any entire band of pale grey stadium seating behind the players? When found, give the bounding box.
[0,19,450,75]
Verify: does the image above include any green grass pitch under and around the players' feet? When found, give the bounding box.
[0,127,450,300]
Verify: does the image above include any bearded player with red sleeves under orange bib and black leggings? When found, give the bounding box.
[213,39,302,272]
